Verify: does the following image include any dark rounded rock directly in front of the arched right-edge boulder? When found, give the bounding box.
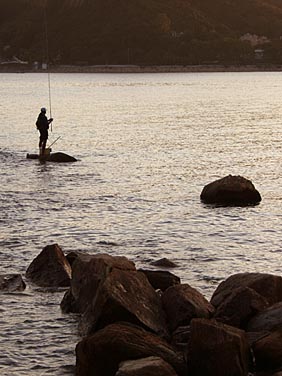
[214,287,268,329]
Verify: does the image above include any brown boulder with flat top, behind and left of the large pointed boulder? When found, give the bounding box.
[61,254,136,313]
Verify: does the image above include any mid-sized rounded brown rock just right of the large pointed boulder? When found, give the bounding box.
[162,284,214,331]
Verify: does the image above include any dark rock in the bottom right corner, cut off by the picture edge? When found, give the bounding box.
[253,327,282,371]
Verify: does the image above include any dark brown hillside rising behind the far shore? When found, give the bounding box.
[0,0,282,64]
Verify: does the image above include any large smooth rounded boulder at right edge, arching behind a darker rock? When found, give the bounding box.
[211,273,282,307]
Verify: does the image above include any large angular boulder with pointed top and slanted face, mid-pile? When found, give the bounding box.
[80,269,168,337]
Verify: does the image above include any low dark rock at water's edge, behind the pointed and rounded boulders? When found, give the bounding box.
[138,269,180,291]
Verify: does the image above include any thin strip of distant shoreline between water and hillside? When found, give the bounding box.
[0,63,282,73]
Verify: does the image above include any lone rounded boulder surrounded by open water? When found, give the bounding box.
[201,175,261,205]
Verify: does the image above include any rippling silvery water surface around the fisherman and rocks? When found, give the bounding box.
[0,73,282,376]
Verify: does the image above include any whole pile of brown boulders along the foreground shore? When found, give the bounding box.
[19,245,282,376]
